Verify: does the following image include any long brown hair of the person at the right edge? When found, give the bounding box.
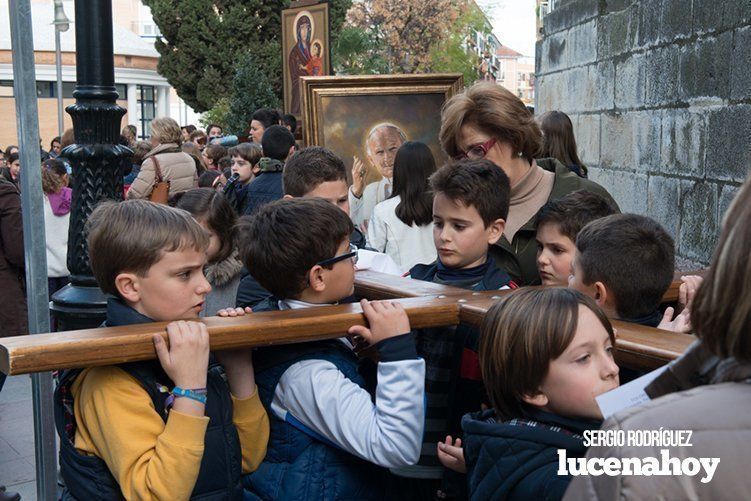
[691,172,751,362]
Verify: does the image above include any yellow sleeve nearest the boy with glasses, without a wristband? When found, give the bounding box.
[232,388,269,474]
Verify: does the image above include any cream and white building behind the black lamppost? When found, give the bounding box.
[0,0,196,149]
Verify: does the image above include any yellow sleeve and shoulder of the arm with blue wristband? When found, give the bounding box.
[72,367,209,500]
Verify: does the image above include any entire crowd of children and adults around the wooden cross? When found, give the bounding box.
[0,82,751,500]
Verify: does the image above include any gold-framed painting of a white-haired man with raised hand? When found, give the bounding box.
[302,73,463,184]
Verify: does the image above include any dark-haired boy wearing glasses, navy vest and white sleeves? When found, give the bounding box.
[235,198,425,499]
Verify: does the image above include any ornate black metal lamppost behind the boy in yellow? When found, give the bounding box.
[51,0,132,331]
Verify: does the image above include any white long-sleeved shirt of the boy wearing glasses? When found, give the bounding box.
[271,301,425,468]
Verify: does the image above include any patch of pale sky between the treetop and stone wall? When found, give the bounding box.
[477,0,536,57]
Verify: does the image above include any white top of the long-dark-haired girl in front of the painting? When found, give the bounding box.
[368,196,437,273]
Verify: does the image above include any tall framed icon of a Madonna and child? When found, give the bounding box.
[282,0,331,119]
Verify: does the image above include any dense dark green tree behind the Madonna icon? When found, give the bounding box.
[143,0,352,112]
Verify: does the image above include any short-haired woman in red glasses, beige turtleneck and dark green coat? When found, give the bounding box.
[440,82,617,285]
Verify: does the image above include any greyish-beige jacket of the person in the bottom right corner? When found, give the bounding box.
[564,342,751,500]
